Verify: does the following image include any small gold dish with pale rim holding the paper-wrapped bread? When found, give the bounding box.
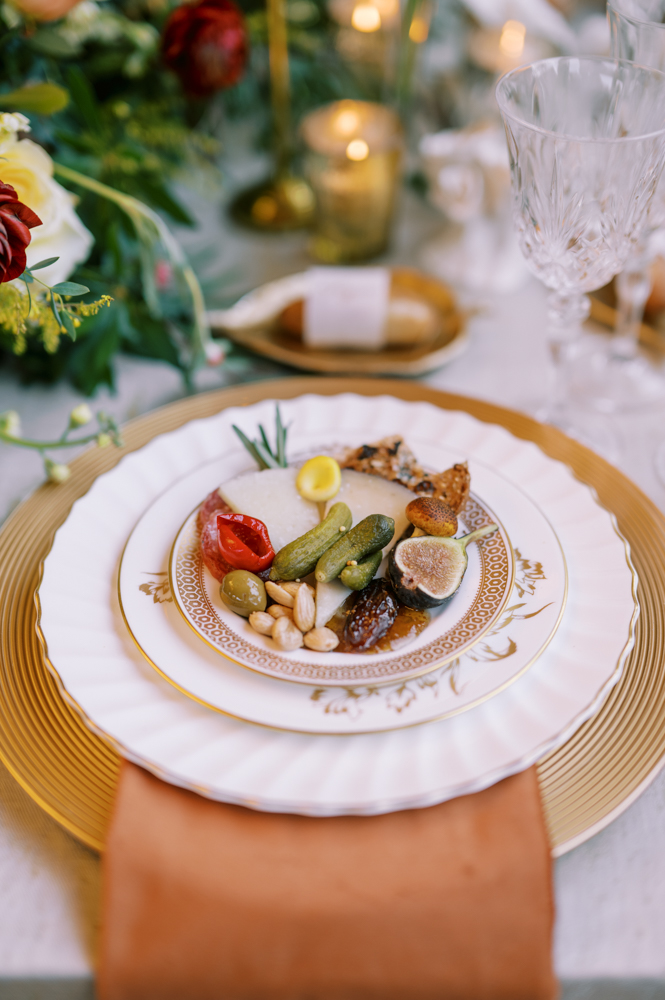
[209,268,468,377]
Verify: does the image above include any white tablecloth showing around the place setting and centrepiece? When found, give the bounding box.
[0,188,665,1000]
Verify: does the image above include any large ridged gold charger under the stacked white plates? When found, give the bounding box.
[0,378,665,855]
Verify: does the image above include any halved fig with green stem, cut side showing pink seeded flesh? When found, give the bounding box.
[388,524,498,608]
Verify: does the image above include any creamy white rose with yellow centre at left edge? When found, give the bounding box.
[0,139,93,285]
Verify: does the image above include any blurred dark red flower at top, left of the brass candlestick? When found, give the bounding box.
[162,0,249,97]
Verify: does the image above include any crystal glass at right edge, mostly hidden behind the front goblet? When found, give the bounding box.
[596,0,665,412]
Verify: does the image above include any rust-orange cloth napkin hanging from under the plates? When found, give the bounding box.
[99,763,557,1000]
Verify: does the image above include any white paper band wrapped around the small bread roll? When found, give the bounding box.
[303,267,390,350]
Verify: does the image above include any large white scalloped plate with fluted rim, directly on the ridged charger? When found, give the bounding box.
[38,394,638,816]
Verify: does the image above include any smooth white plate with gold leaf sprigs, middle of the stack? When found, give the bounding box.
[119,452,567,734]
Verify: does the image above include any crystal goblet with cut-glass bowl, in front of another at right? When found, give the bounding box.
[496,57,665,444]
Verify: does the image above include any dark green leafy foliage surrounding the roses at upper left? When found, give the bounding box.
[0,0,219,393]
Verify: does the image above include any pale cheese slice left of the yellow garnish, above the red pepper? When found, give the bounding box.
[218,469,320,552]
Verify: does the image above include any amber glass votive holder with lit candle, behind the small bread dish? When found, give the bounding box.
[301,101,402,264]
